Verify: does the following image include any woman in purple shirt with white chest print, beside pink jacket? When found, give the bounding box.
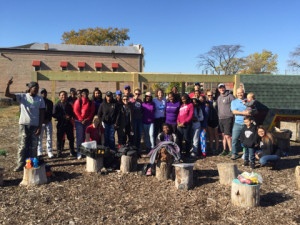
[166,92,180,134]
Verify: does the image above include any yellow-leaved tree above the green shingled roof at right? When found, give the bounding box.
[240,50,278,74]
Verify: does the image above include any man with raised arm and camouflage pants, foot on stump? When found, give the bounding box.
[5,79,45,172]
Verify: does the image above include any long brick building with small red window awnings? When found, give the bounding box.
[0,43,144,96]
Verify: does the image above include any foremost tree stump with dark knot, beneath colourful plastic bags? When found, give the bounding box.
[231,179,260,207]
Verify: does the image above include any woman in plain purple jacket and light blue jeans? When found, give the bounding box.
[142,92,155,152]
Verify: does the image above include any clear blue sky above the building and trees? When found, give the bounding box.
[0,0,300,74]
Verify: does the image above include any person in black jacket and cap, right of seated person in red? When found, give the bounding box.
[98,91,118,150]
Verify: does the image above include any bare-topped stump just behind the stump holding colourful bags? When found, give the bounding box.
[217,163,238,185]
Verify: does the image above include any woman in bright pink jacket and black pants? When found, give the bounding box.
[177,94,194,156]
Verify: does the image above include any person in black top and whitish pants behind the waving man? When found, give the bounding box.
[38,88,54,158]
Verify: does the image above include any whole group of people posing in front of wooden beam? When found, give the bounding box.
[5,79,278,171]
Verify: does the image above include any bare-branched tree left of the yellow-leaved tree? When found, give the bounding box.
[198,45,243,75]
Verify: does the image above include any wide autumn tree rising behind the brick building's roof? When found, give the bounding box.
[62,27,130,46]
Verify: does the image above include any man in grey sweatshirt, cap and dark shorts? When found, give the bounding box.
[217,83,234,156]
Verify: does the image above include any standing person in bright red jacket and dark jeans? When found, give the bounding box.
[73,89,95,159]
